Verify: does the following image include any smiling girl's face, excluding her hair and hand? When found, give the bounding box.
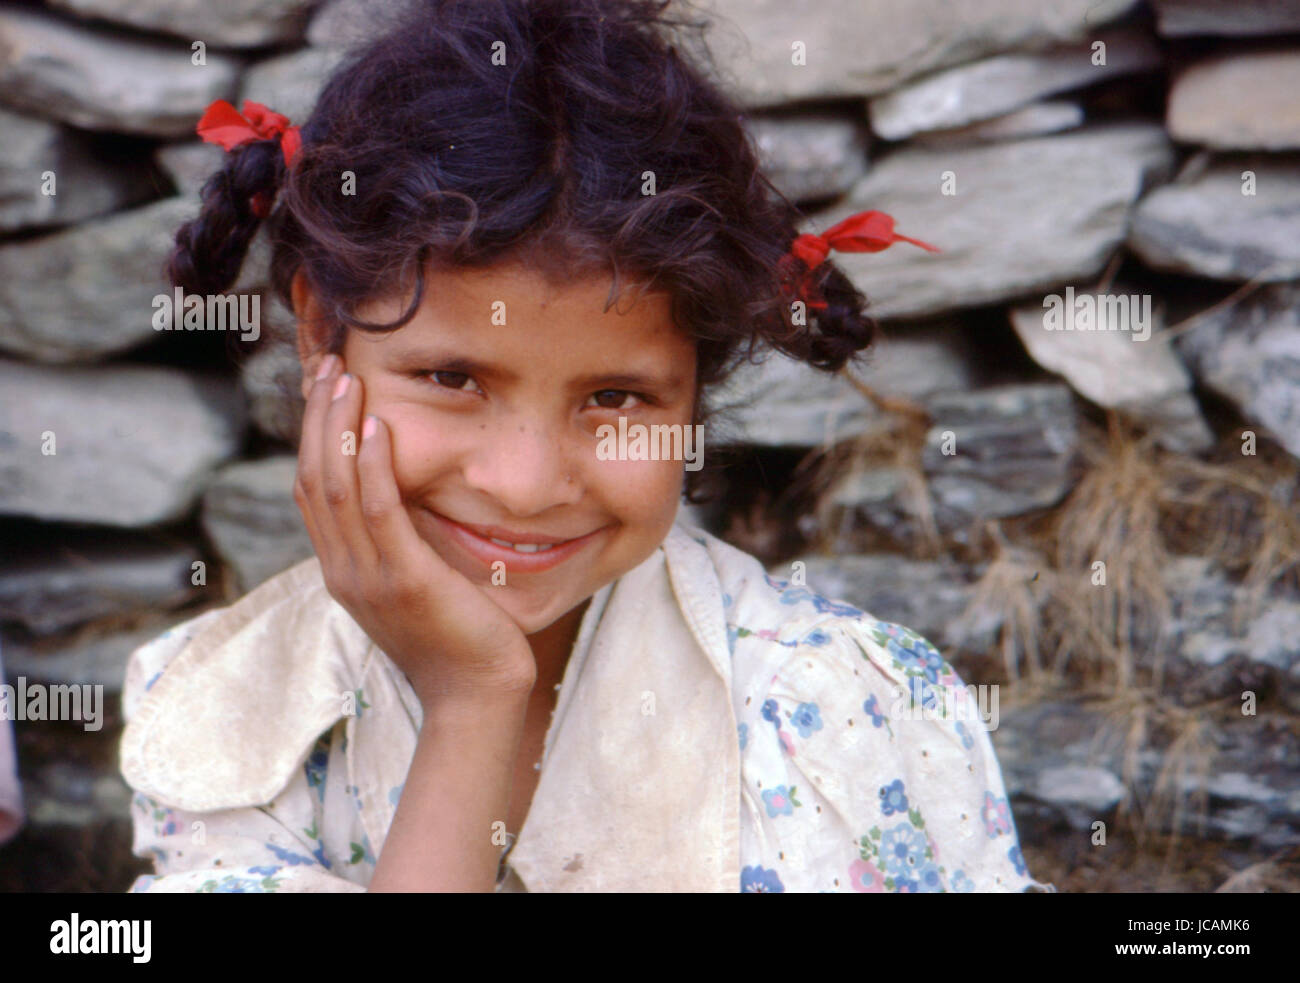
[295,267,696,635]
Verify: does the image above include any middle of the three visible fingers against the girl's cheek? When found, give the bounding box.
[319,373,378,572]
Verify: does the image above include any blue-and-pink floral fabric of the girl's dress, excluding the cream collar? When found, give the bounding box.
[131,525,1050,893]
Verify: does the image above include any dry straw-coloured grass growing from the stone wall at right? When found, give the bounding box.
[790,382,1300,873]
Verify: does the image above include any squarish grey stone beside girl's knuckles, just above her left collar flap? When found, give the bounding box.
[202,454,312,590]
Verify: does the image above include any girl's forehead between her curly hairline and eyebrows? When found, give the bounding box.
[358,265,694,376]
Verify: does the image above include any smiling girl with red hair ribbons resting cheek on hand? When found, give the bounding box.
[122,0,1054,892]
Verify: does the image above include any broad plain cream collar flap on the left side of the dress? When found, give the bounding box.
[121,558,373,811]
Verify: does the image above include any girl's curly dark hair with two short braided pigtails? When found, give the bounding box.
[166,0,876,503]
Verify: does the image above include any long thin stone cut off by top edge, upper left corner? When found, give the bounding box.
[49,0,316,48]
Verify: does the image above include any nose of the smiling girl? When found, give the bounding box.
[464,416,582,518]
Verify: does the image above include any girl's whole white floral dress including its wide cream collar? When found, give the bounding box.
[124,525,1056,893]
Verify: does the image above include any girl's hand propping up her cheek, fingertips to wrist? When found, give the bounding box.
[294,355,537,707]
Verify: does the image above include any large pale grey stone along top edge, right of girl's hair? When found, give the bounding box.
[709,0,1135,105]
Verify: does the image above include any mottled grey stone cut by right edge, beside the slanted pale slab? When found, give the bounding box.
[1175,283,1300,458]
